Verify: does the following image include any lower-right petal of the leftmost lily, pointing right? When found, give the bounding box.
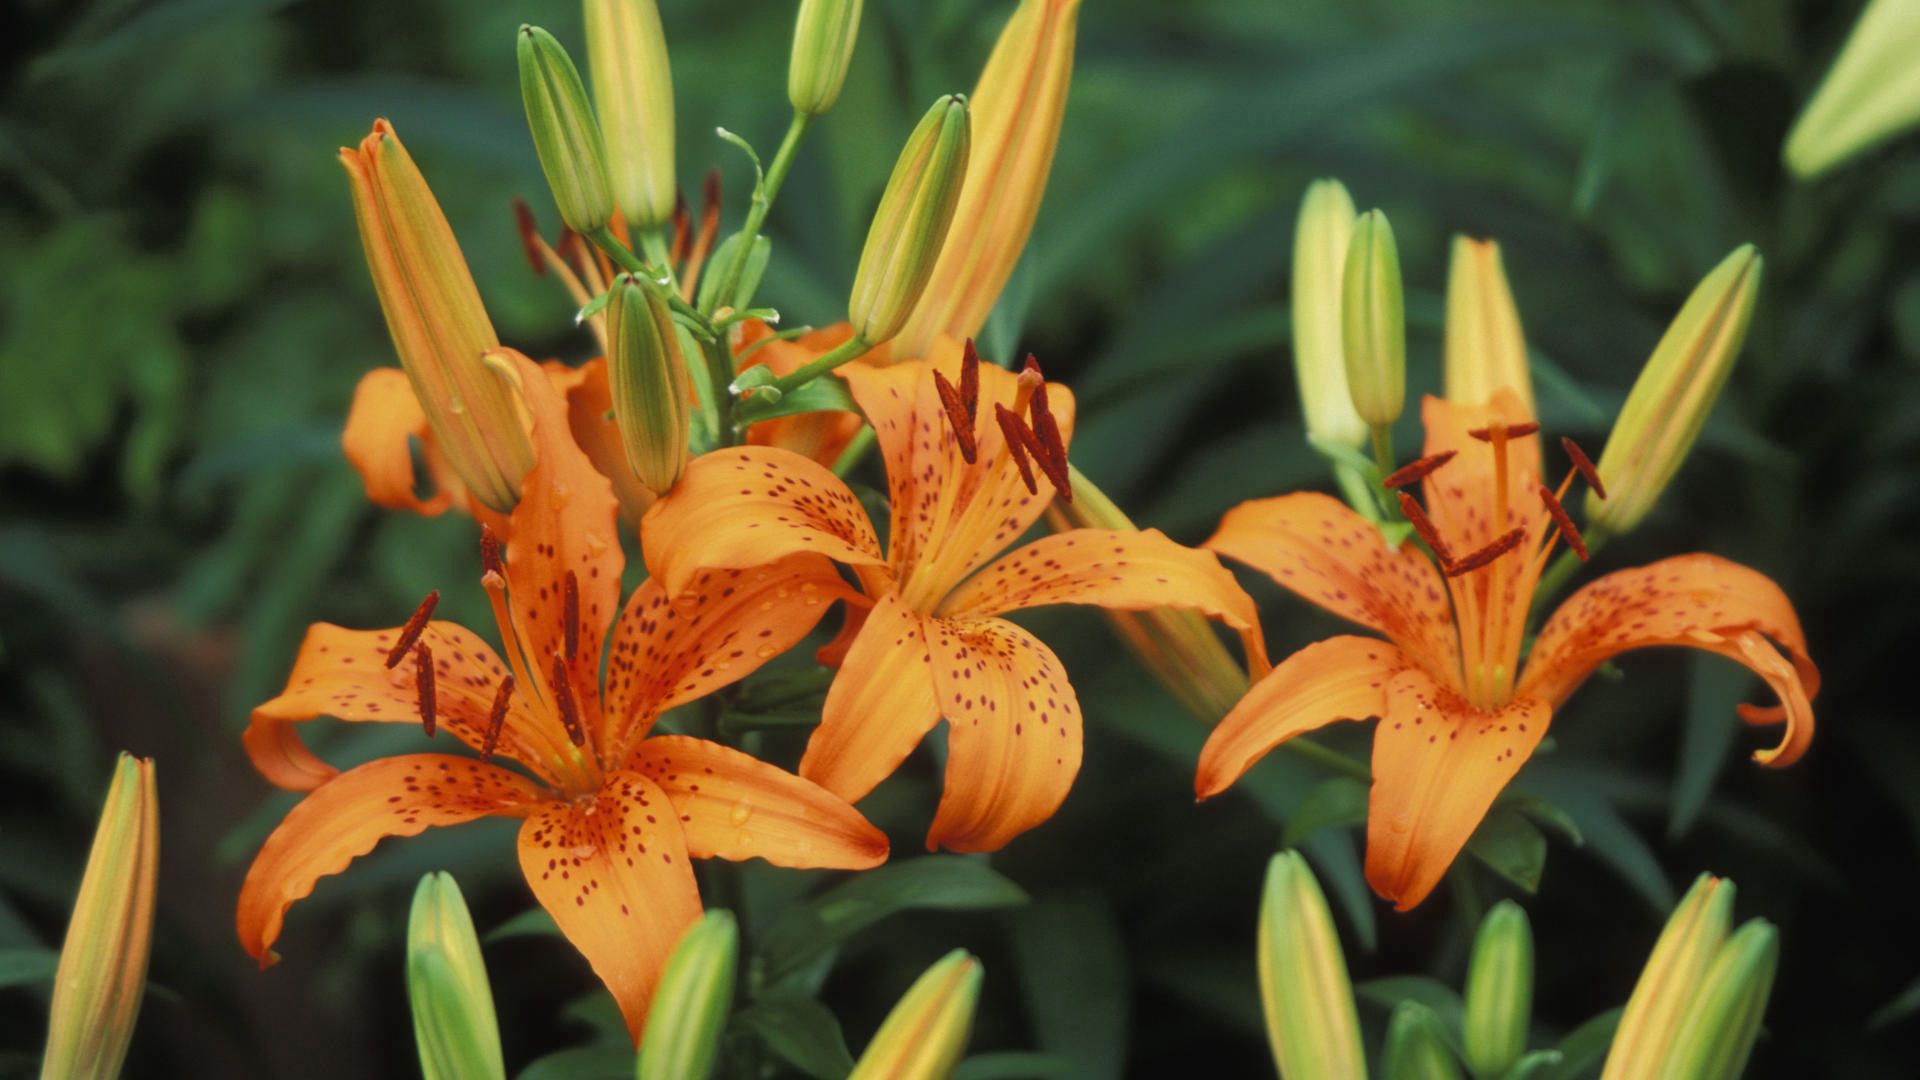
[632,736,887,871]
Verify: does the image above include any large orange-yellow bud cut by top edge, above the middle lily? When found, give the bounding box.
[893,0,1081,359]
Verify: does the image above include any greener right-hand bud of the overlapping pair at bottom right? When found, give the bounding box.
[1661,919,1780,1080]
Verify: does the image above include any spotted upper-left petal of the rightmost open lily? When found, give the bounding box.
[1204,492,1459,671]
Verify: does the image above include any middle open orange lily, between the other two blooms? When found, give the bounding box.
[641,344,1260,851]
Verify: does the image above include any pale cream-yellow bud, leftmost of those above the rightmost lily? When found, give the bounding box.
[1294,181,1367,448]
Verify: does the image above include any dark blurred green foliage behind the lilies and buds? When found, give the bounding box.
[0,0,1920,1076]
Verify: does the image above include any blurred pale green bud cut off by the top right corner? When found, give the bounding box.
[1784,0,1920,181]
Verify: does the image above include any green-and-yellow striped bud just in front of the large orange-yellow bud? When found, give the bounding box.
[847,94,972,344]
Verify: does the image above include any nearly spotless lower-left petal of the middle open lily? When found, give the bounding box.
[801,594,941,801]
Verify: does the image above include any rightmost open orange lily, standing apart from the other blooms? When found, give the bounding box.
[1194,388,1820,911]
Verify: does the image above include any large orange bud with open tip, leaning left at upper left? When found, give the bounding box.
[340,119,534,513]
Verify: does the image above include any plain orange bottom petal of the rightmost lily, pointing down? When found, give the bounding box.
[1367,667,1551,911]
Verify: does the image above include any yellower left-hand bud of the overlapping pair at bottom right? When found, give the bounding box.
[1599,874,1734,1080]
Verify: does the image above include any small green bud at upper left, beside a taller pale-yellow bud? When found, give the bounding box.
[518,25,612,236]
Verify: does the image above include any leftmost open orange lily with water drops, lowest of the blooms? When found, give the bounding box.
[236,343,887,1040]
